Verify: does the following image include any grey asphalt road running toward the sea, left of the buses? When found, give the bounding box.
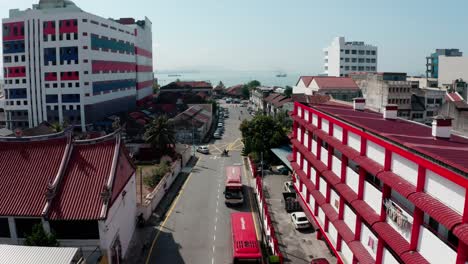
[147,102,254,264]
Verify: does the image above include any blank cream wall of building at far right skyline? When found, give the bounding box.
[439,56,468,85]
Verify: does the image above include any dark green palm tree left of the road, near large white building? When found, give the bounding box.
[144,116,175,153]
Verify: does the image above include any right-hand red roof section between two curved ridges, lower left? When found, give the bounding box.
[49,139,116,220]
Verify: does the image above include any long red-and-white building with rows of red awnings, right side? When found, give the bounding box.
[291,98,468,264]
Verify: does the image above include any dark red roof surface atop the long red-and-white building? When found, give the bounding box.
[314,105,468,173]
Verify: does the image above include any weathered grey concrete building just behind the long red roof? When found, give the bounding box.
[350,72,412,119]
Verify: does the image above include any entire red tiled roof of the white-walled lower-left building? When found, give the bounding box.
[0,133,135,220]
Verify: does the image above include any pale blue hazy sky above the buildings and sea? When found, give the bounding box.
[0,0,468,74]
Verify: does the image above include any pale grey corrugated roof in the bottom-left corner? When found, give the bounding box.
[0,245,78,264]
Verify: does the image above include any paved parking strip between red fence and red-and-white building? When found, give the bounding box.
[263,170,336,264]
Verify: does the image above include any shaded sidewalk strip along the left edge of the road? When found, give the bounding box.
[123,156,198,264]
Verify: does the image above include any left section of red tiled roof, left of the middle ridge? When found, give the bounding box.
[0,137,67,216]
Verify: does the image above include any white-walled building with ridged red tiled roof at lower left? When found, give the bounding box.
[0,132,137,263]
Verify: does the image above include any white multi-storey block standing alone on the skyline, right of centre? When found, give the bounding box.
[323,37,377,77]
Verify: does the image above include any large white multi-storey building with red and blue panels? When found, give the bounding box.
[2,0,153,130]
